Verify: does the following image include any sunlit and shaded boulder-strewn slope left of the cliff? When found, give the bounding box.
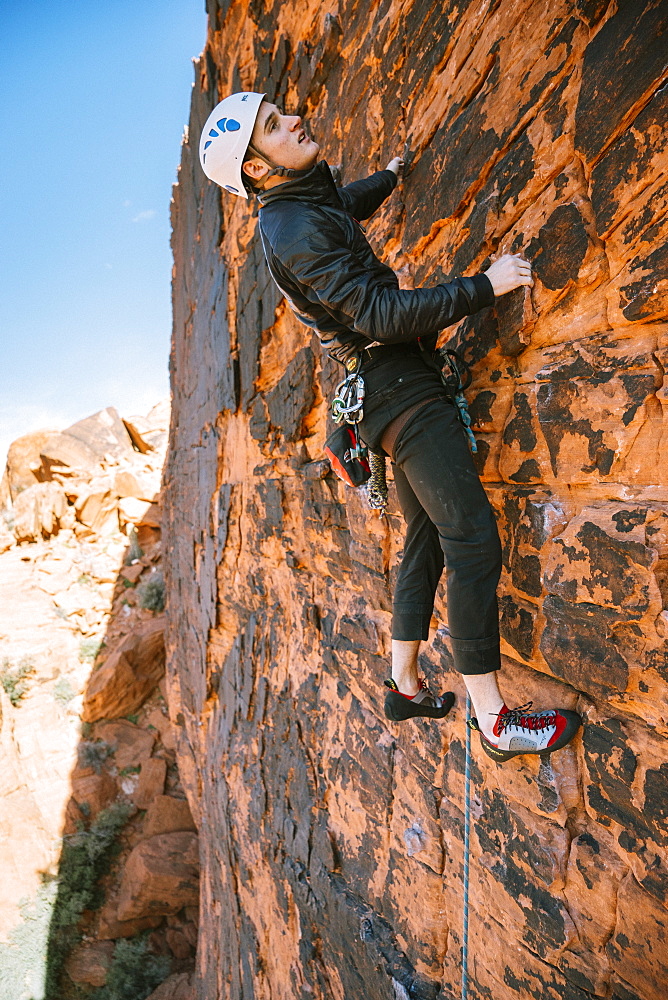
[0,403,199,1000]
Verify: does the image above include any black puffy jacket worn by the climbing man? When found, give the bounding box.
[259,160,494,361]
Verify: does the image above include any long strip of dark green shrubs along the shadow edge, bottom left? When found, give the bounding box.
[45,802,134,1000]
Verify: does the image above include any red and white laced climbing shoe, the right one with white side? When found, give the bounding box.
[470,701,582,761]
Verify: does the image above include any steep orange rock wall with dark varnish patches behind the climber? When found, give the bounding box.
[164,0,668,1000]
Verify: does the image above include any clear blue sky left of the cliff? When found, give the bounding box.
[0,0,206,468]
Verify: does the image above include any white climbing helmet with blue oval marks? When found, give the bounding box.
[199,91,265,198]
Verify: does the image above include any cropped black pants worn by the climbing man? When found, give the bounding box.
[360,348,501,674]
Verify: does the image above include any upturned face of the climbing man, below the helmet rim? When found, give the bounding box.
[243,101,320,187]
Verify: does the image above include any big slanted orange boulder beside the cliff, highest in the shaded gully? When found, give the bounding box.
[83,616,165,722]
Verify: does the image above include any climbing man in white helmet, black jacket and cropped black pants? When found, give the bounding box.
[200,92,580,761]
